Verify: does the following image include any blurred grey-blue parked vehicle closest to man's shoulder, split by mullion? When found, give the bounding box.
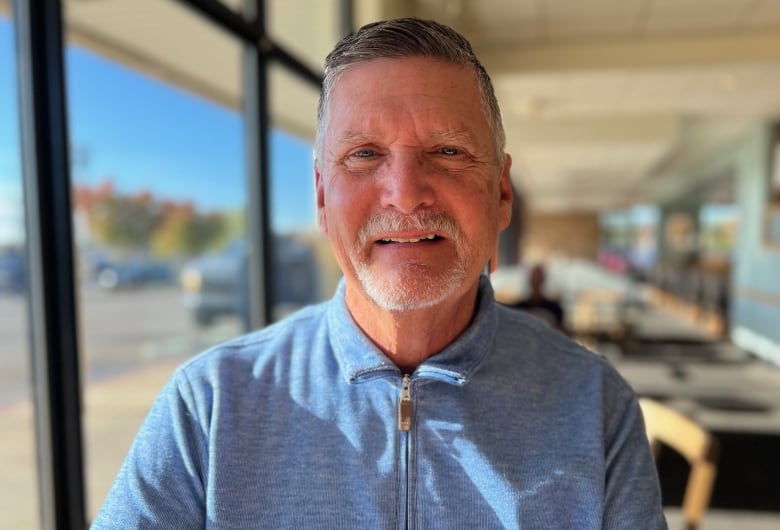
[181,237,319,325]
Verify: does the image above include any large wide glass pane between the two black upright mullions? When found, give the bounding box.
[66,2,246,516]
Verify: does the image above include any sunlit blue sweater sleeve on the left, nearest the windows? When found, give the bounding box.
[91,370,209,530]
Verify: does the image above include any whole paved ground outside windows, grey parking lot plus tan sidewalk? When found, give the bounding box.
[0,286,239,530]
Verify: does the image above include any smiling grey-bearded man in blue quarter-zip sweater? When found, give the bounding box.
[94,19,665,530]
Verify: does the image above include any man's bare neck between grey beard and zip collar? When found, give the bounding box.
[346,285,477,373]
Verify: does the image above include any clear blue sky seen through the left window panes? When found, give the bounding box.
[0,18,314,245]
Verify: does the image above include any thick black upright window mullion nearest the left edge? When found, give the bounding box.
[13,0,86,530]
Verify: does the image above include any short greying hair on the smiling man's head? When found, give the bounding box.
[315,18,506,160]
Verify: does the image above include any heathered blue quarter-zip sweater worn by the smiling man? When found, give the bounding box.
[93,277,666,530]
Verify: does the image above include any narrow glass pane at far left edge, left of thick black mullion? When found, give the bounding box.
[0,10,40,530]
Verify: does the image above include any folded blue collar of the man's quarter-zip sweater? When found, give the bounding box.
[327,275,498,385]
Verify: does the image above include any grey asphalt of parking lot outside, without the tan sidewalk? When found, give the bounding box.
[0,286,239,407]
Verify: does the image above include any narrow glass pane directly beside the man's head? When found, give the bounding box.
[269,66,341,318]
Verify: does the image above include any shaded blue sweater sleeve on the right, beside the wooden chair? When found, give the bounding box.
[603,380,668,530]
